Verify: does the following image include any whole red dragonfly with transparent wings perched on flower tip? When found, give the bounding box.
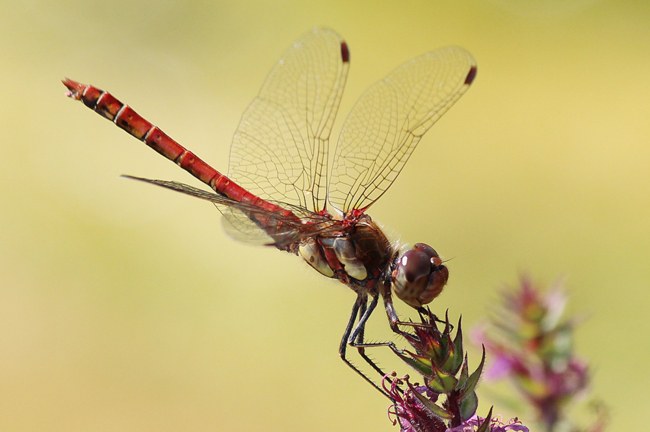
[63,28,476,397]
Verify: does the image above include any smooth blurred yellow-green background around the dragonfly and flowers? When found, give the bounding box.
[0,0,650,432]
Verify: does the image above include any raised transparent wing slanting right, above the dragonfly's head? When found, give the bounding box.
[329,47,476,212]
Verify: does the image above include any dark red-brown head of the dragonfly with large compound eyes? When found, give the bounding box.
[392,243,449,309]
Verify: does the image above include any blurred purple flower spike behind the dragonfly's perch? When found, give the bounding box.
[472,278,589,431]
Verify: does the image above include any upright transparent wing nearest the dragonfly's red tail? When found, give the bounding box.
[228,28,349,212]
